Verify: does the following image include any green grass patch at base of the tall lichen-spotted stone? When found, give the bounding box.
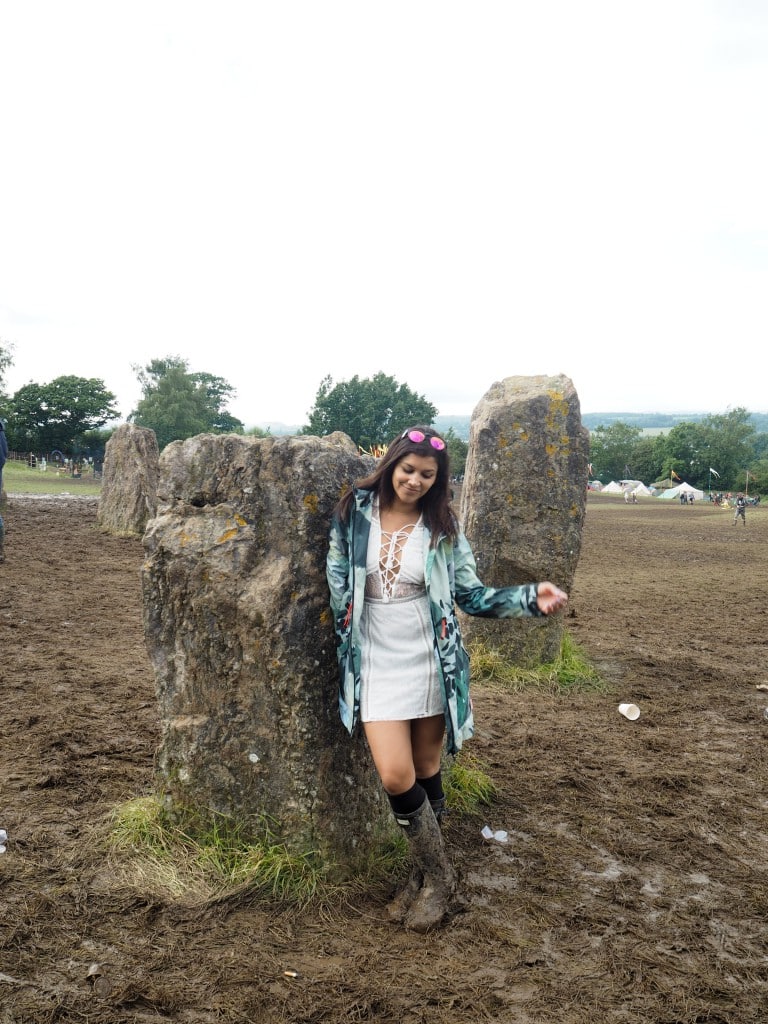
[470,632,607,693]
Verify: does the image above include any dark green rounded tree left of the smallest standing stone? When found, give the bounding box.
[8,376,120,455]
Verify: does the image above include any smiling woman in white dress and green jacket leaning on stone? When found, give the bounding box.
[328,427,567,932]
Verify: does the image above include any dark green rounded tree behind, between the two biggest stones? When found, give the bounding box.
[301,373,437,450]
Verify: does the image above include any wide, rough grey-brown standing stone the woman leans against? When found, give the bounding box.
[142,433,391,873]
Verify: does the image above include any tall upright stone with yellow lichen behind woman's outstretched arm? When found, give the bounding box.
[461,376,589,667]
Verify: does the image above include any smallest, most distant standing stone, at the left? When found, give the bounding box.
[97,423,160,537]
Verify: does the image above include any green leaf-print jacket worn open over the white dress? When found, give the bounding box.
[327,489,542,754]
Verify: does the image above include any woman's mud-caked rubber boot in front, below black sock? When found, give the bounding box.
[395,800,456,932]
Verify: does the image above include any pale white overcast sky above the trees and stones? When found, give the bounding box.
[0,0,768,425]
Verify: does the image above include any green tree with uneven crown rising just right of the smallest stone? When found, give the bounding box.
[129,356,243,450]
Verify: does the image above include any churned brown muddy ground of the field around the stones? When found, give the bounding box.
[0,496,768,1024]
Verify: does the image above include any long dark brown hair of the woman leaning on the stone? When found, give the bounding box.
[336,426,459,545]
